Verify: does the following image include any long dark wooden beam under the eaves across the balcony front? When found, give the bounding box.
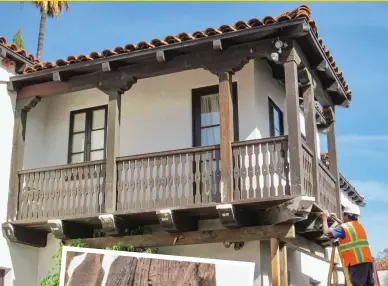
[14,39,273,99]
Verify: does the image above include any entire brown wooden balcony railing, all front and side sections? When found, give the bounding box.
[12,136,337,221]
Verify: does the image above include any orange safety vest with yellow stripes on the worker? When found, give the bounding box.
[339,221,373,267]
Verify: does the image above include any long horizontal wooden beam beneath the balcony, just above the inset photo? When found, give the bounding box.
[64,224,295,249]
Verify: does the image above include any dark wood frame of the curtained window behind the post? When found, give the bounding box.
[192,82,239,147]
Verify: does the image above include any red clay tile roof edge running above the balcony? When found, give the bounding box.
[19,5,351,96]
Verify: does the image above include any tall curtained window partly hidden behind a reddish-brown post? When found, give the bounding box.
[193,82,238,146]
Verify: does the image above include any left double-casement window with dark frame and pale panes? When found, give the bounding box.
[68,106,107,163]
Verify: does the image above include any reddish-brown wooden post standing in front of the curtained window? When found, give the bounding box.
[218,72,234,203]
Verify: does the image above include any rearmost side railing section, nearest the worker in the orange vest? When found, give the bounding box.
[318,161,339,213]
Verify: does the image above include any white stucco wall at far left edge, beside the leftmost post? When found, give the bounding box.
[0,63,38,286]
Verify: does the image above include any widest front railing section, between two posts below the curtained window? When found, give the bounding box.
[117,145,221,211]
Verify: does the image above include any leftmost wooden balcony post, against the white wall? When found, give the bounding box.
[8,108,28,221]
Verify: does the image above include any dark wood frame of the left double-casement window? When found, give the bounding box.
[67,105,108,164]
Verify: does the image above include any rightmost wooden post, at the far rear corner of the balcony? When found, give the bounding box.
[327,105,342,218]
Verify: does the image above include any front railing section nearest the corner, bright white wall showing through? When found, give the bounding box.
[232,136,290,201]
